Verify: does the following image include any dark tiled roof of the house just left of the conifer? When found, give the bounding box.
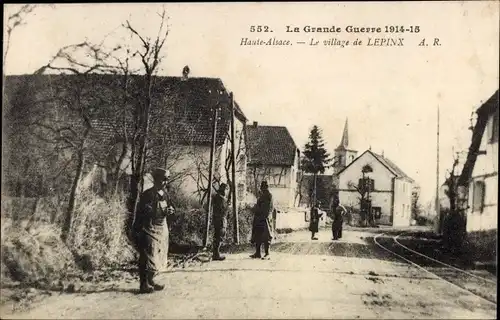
[247,125,297,166]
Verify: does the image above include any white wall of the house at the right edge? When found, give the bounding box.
[467,117,498,232]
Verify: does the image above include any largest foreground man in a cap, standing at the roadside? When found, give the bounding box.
[134,168,174,293]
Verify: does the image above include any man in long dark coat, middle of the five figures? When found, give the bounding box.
[250,181,273,259]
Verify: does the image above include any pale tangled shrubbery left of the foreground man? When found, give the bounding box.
[1,190,133,281]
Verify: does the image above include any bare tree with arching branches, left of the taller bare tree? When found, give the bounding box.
[32,42,118,242]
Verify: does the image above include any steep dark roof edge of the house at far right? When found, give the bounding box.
[458,90,499,186]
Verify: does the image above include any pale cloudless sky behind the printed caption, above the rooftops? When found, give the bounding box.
[4,1,499,201]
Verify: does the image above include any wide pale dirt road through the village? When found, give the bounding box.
[2,231,496,319]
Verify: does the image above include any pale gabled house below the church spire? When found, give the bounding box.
[337,150,414,227]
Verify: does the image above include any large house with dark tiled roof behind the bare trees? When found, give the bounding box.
[5,74,247,204]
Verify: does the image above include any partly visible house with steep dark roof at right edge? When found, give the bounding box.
[458,90,499,260]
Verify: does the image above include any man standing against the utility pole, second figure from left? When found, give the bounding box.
[212,183,227,261]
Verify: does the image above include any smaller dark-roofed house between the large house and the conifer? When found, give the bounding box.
[247,122,300,208]
